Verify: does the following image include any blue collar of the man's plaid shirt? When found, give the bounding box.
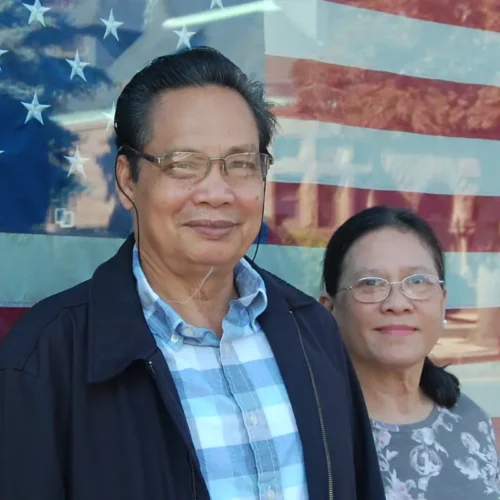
[132,244,267,350]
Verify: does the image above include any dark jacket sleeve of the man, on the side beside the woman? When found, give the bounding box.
[344,348,386,500]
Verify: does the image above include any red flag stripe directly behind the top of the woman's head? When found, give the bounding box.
[266,182,500,252]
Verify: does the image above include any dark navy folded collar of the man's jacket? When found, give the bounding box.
[88,235,315,382]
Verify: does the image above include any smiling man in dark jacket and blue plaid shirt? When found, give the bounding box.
[0,48,384,500]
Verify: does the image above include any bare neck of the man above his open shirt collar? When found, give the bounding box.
[141,247,238,336]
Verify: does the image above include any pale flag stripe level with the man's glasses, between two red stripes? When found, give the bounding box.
[269,118,500,196]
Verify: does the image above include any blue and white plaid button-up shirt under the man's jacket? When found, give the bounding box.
[133,248,308,500]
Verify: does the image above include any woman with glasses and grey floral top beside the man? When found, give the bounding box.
[321,207,500,500]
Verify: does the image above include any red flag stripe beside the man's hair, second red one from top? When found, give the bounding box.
[266,56,500,140]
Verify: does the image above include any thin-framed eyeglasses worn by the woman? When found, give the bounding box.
[338,274,444,304]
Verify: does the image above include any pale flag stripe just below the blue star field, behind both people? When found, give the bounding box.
[0,234,500,308]
